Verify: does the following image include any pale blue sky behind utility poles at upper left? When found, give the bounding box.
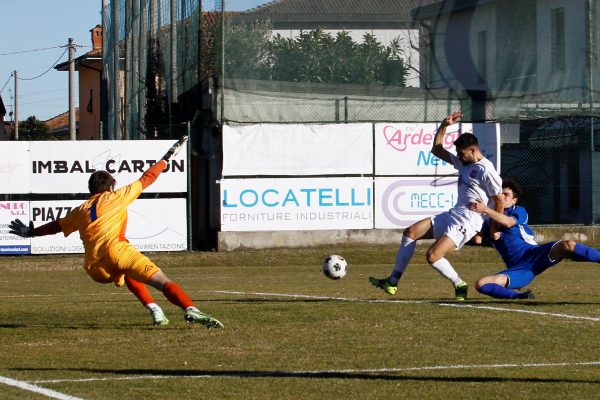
[0,0,269,121]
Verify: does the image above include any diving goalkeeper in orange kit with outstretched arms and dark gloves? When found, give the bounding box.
[10,137,223,328]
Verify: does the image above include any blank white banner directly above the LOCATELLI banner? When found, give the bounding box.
[223,124,373,176]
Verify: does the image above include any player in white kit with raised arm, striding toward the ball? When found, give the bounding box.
[369,112,504,301]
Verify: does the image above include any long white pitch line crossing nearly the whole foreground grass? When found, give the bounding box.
[34,361,600,383]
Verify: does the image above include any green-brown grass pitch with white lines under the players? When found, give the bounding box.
[0,245,600,400]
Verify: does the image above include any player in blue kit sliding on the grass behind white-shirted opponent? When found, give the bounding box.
[469,178,600,299]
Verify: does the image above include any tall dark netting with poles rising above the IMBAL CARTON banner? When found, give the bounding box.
[103,0,209,139]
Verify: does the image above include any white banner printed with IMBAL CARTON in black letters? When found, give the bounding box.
[28,140,187,193]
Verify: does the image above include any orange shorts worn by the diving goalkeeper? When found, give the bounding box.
[84,242,160,287]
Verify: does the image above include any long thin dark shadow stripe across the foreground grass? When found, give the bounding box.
[9,368,600,384]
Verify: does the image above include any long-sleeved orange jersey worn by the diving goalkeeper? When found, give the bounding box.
[59,160,167,270]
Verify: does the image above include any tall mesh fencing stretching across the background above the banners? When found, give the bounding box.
[103,0,600,224]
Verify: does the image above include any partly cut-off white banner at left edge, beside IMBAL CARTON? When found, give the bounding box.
[0,142,30,194]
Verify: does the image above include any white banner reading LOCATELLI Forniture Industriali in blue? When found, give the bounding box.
[221,178,373,231]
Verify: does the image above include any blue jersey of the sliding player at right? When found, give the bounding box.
[482,206,538,268]
